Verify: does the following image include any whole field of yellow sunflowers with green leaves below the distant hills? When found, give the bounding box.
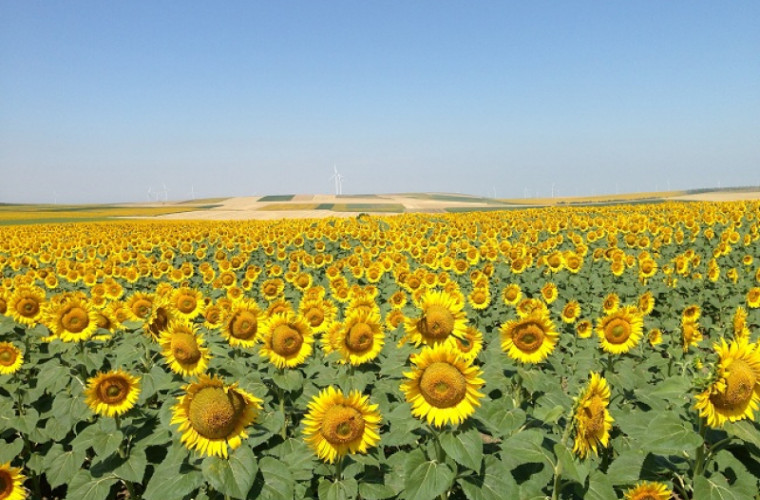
[0,202,760,500]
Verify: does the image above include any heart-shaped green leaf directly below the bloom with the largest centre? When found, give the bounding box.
[202,446,258,498]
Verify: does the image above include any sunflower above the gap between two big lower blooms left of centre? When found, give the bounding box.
[259,313,314,369]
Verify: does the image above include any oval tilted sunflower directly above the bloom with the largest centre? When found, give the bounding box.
[158,321,209,377]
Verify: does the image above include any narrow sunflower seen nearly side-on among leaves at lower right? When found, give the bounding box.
[573,372,614,458]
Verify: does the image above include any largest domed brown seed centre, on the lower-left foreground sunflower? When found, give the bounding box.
[188,387,245,439]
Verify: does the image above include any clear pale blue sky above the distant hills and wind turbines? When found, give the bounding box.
[0,0,760,203]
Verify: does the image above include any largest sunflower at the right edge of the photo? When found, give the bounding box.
[695,339,760,427]
